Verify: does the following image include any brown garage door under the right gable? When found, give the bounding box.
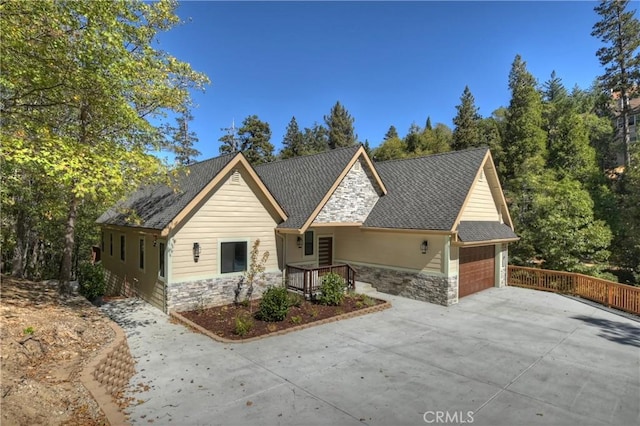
[458,246,496,297]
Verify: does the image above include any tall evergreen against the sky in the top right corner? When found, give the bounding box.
[591,0,640,167]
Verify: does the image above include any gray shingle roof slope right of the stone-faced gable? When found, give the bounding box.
[363,148,488,231]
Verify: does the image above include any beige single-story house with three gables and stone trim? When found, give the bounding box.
[98,146,518,311]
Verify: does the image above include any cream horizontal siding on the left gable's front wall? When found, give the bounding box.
[170,169,279,282]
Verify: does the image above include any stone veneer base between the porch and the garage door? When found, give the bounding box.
[352,265,458,306]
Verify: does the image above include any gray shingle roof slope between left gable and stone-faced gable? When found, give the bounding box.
[255,145,360,229]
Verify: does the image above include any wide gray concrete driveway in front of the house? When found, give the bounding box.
[104,287,640,425]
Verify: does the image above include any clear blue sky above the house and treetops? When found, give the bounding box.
[158,1,616,160]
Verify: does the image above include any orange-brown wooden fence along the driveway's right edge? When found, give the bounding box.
[508,265,640,315]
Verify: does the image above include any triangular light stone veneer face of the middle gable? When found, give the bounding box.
[314,159,380,223]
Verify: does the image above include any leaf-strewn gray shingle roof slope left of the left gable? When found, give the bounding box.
[97,154,236,229]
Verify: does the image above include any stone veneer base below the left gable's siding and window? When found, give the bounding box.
[167,272,282,312]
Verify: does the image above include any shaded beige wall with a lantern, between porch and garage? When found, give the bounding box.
[334,228,445,273]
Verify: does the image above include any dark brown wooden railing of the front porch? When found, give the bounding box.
[286,264,356,297]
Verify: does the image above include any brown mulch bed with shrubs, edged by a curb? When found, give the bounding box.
[180,294,386,340]
